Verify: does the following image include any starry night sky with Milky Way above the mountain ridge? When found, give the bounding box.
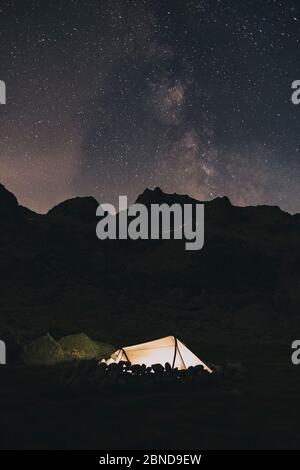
[0,0,300,213]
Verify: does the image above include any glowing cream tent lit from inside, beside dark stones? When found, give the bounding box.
[103,336,212,372]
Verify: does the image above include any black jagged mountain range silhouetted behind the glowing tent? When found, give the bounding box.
[0,185,300,354]
